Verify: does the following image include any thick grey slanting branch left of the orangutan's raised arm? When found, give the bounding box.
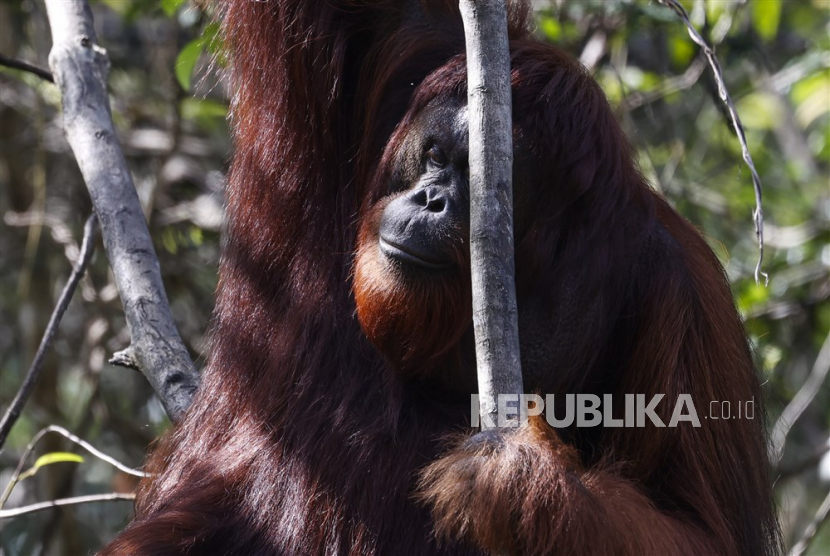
[46,0,199,421]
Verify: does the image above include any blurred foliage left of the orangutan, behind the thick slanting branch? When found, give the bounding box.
[0,0,224,556]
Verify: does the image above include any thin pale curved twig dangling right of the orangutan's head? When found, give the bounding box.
[658,0,769,285]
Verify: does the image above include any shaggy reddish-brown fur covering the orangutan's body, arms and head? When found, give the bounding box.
[102,0,778,556]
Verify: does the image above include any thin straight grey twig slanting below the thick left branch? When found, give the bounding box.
[0,214,98,448]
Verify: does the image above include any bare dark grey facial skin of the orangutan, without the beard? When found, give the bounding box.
[378,104,469,272]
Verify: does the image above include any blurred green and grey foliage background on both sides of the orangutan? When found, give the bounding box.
[0,0,830,555]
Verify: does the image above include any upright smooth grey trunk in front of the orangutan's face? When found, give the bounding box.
[461,0,522,430]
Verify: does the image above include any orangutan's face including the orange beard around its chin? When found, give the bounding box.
[354,98,546,378]
